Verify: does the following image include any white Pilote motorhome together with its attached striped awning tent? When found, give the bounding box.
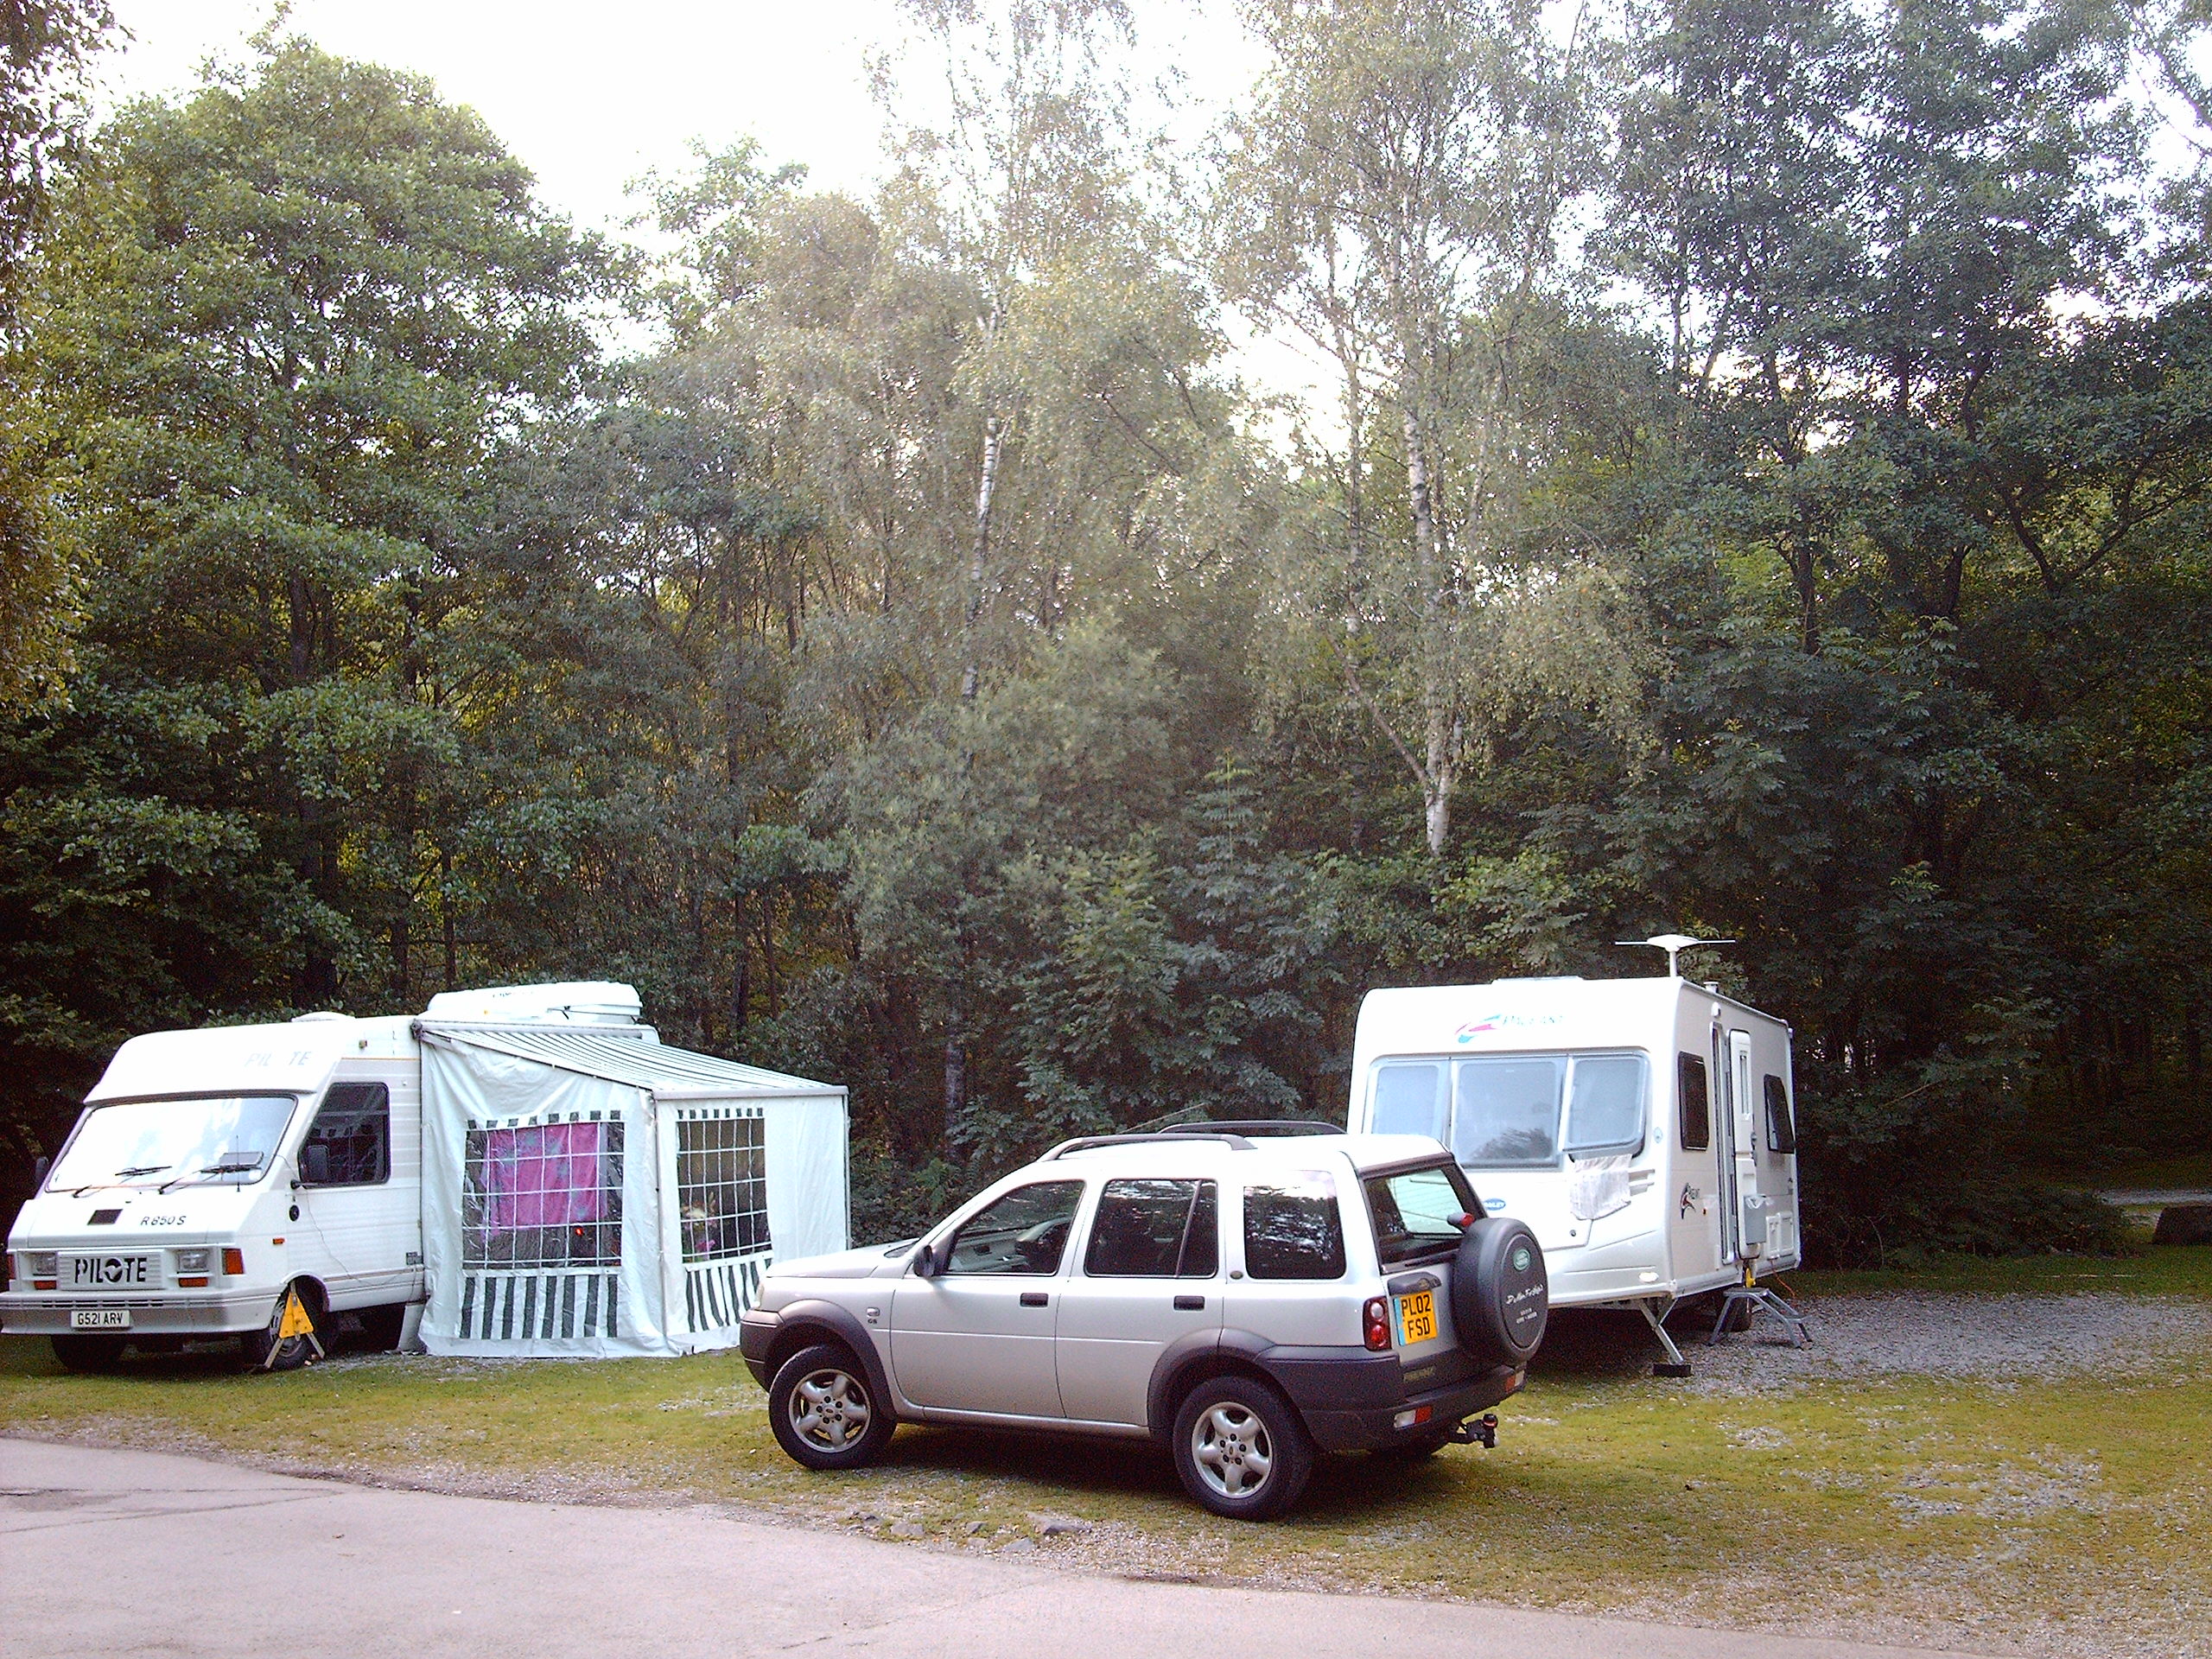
[0,982,847,1370]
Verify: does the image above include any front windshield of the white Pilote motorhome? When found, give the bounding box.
[47,1095,299,1192]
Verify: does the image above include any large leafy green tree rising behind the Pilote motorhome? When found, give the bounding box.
[0,42,604,1185]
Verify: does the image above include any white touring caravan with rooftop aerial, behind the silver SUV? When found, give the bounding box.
[1350,971,1801,1367]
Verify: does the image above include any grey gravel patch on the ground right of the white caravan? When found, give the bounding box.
[1675,1292,2212,1394]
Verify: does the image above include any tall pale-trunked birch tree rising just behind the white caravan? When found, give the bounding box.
[1217,0,1635,854]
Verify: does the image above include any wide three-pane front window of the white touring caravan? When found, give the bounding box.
[1371,1053,1650,1170]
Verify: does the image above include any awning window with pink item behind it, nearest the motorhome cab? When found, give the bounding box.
[460,1113,621,1269]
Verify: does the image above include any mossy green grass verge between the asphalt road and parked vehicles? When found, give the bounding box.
[0,1248,2212,1655]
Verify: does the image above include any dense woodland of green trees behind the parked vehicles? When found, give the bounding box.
[0,0,2212,1256]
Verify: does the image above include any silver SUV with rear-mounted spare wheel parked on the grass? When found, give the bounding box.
[741,1123,1546,1520]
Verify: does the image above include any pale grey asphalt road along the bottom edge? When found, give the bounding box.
[0,1438,1999,1659]
